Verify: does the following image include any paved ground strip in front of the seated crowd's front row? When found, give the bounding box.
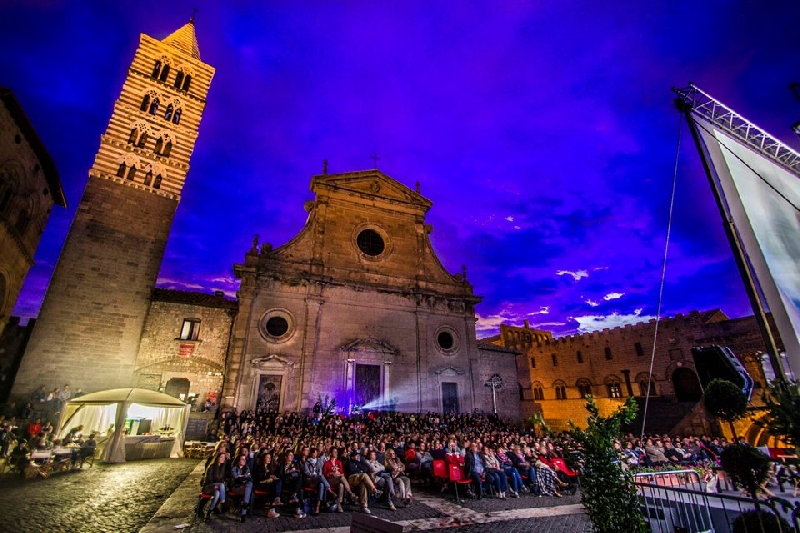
[142,462,591,533]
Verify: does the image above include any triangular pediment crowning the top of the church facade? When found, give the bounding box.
[311,170,431,211]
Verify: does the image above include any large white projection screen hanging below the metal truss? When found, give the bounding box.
[695,123,800,376]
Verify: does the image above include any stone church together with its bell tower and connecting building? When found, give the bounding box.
[9,21,520,418]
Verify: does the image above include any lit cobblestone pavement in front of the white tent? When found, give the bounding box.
[0,459,198,533]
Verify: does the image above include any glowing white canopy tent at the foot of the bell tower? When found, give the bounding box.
[58,388,189,463]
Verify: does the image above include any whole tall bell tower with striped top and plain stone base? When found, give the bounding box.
[13,18,214,395]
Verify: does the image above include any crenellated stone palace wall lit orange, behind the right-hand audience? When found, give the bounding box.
[492,310,776,428]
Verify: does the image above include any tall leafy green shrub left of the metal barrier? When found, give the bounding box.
[569,395,650,533]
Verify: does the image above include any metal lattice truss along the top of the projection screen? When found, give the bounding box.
[673,84,800,178]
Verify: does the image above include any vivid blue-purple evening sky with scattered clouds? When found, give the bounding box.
[0,0,800,336]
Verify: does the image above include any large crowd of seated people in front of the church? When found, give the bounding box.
[204,411,592,520]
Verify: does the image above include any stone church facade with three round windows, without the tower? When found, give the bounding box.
[223,170,518,414]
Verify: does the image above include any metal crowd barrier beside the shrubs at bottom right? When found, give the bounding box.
[634,470,791,533]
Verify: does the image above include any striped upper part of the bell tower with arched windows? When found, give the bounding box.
[89,22,214,201]
